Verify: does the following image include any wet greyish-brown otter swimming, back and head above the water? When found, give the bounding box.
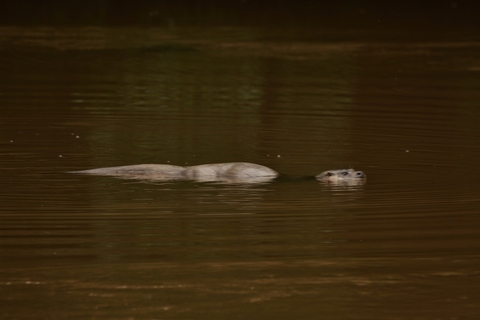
[70,162,366,184]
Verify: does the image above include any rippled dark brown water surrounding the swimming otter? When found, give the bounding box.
[0,21,480,319]
